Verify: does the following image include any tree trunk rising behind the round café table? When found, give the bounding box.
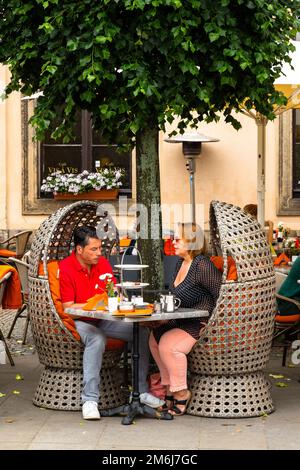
[136,127,164,301]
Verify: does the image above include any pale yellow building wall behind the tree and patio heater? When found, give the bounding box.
[0,66,300,234]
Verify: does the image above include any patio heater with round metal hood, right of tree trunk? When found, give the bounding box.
[164,132,220,223]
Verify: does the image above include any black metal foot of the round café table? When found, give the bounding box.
[101,400,173,424]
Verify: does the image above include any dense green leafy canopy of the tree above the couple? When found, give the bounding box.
[0,0,300,141]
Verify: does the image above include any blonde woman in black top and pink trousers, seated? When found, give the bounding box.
[149,224,222,415]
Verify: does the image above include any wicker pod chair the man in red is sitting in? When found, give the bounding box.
[28,201,125,410]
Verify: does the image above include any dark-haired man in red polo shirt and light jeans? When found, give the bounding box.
[59,227,164,419]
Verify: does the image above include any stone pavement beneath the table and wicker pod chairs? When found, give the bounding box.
[0,311,300,451]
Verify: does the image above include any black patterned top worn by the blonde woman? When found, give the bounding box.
[153,255,222,342]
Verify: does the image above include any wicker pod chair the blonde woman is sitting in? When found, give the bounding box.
[188,201,276,418]
